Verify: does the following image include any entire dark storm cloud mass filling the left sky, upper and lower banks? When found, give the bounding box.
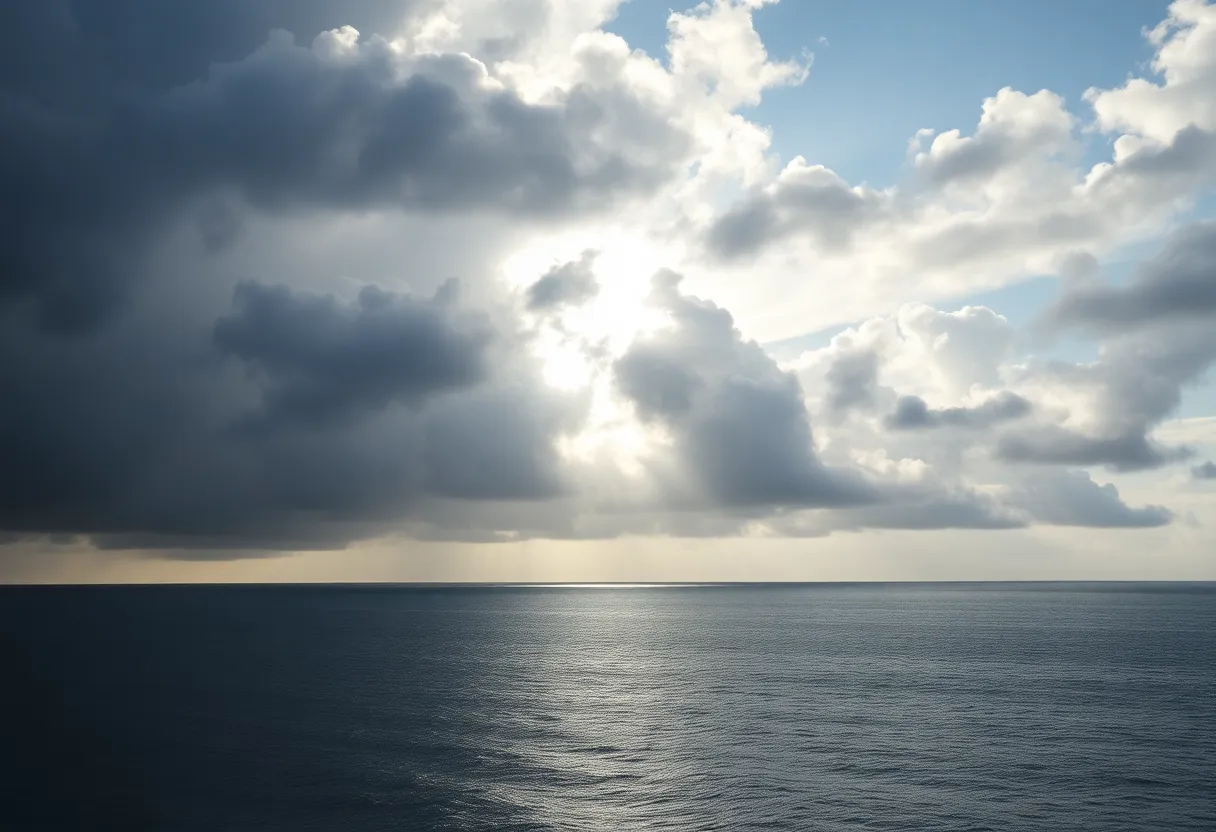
[0,0,685,556]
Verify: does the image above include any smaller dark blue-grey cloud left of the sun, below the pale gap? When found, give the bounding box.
[214,283,492,420]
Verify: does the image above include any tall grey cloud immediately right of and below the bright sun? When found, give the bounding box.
[615,272,876,507]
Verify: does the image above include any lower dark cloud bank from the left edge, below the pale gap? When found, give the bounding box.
[0,267,586,557]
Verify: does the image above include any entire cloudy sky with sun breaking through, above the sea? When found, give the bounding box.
[0,0,1216,583]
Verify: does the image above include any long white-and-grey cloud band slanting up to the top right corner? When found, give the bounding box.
[697,9,1216,339]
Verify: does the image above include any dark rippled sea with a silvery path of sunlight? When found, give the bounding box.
[0,585,1216,832]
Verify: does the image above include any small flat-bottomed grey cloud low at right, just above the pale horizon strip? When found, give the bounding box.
[1010,471,1173,528]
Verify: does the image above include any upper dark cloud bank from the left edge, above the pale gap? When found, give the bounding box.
[0,4,686,330]
